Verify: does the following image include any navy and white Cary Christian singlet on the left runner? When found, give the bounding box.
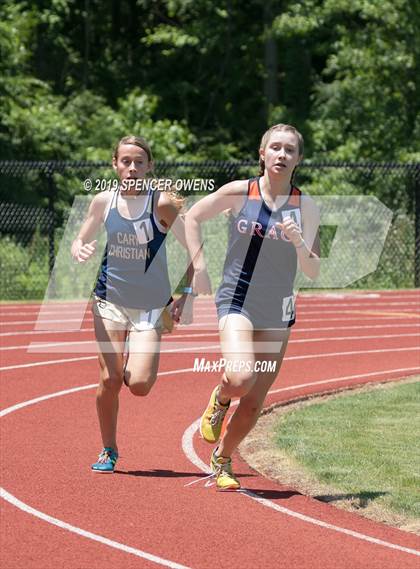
[94,190,171,310]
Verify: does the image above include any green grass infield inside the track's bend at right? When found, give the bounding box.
[275,382,420,518]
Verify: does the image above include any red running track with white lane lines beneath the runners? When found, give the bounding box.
[0,291,420,569]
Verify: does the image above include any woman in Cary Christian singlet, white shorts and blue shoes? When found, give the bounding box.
[72,136,193,473]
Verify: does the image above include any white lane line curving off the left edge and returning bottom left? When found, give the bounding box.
[0,368,199,569]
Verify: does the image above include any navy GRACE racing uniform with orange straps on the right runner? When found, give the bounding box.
[216,178,302,329]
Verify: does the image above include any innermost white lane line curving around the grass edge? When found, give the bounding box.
[182,366,420,556]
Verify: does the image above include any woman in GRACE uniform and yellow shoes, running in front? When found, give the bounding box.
[185,124,319,490]
